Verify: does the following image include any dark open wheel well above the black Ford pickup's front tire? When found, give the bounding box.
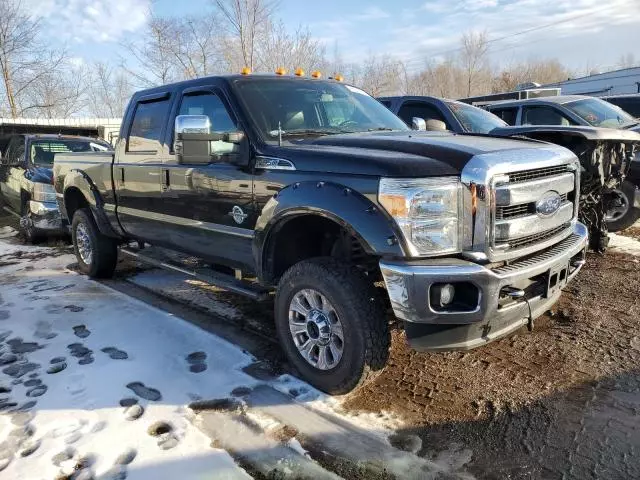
[264,215,377,283]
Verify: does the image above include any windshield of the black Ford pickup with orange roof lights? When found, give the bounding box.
[236,78,409,141]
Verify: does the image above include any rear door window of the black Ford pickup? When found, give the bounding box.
[127,98,169,152]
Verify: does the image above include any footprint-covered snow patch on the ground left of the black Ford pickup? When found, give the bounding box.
[0,237,255,480]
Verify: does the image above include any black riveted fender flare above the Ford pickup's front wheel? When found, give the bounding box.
[253,181,406,283]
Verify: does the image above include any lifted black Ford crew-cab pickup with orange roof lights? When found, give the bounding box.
[54,75,588,393]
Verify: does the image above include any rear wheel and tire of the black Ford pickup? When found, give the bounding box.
[71,208,118,278]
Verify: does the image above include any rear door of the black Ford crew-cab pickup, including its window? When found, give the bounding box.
[113,92,171,242]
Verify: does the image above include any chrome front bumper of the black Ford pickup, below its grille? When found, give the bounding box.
[380,223,588,350]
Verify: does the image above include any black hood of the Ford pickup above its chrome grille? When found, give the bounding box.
[264,131,559,177]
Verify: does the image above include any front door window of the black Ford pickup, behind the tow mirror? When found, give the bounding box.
[178,92,238,155]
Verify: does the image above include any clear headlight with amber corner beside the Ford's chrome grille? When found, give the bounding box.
[378,177,462,256]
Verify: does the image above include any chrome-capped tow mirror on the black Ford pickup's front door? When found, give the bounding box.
[173,115,249,164]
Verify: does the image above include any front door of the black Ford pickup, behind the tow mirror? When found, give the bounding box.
[162,86,256,268]
